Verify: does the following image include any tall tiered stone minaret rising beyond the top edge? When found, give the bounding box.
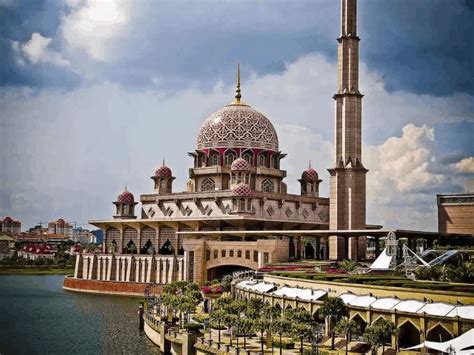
[328,0,367,260]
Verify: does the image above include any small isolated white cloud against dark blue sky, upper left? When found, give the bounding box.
[12,32,70,67]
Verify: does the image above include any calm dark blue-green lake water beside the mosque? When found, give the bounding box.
[0,275,159,355]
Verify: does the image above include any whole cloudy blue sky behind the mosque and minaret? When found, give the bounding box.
[0,0,474,231]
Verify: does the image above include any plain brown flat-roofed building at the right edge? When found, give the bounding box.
[436,193,474,235]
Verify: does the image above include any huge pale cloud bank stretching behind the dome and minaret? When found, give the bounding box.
[0,55,473,230]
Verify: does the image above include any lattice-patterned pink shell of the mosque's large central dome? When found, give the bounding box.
[197,105,278,151]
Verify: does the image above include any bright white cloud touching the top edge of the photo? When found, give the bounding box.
[61,0,132,61]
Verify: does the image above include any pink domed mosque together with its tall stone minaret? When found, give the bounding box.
[66,1,460,290]
